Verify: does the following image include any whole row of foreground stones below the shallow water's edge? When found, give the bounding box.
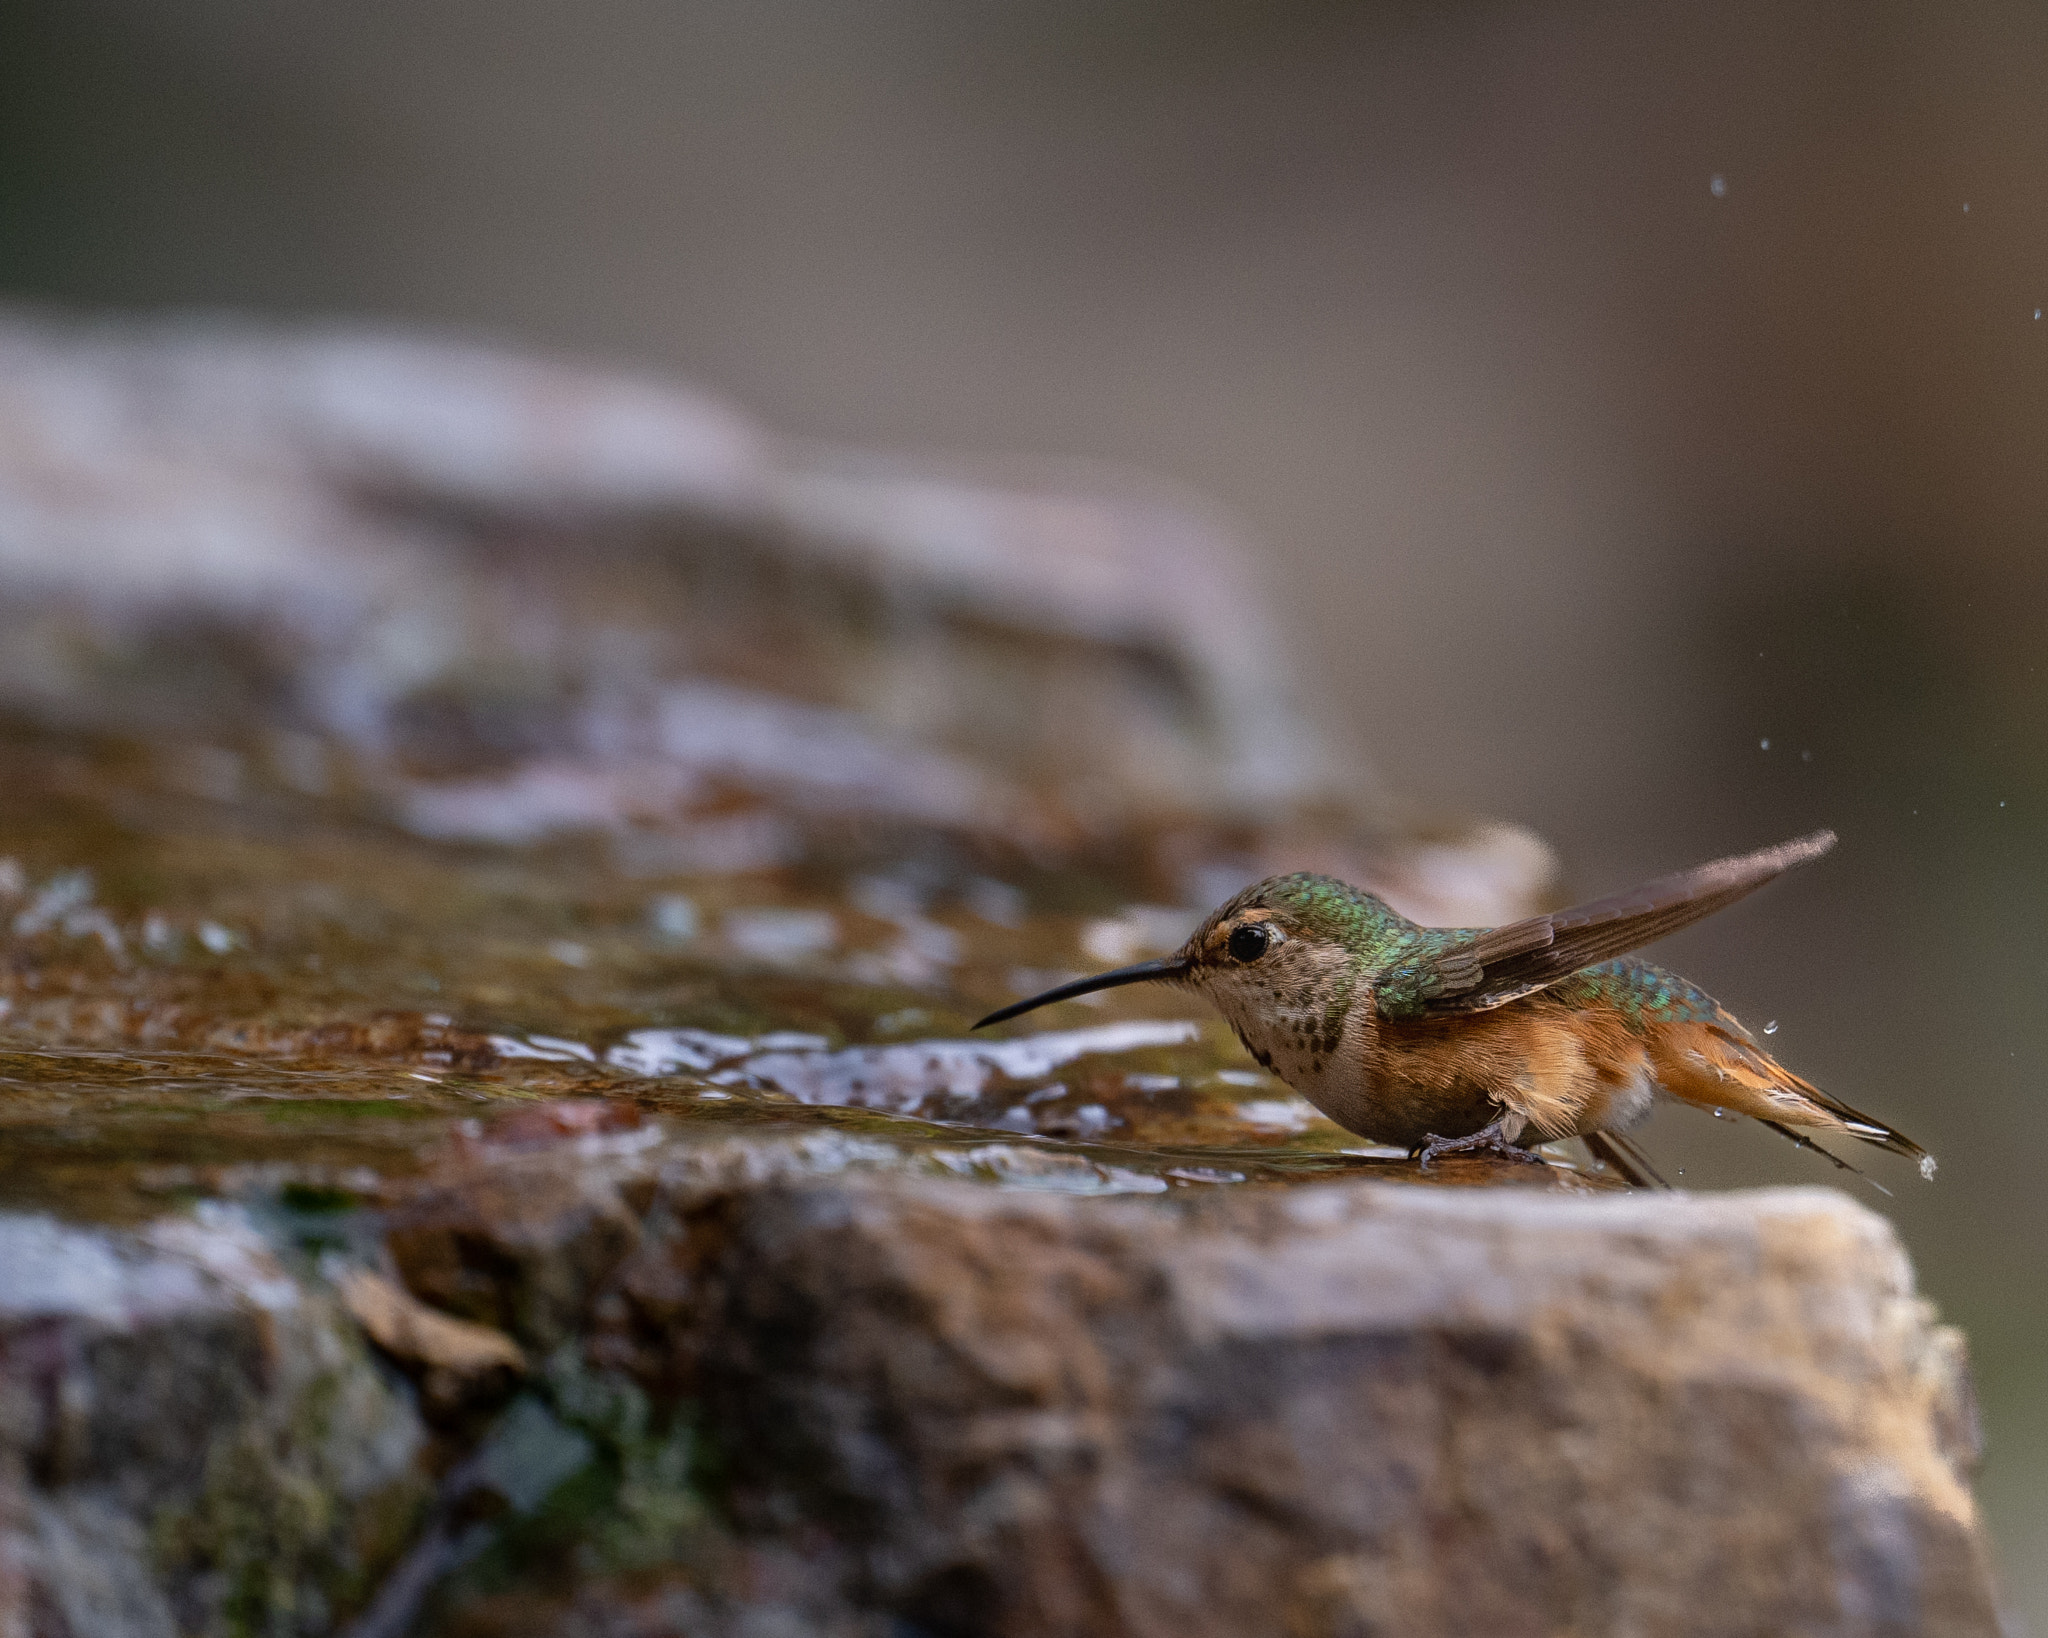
[0,1128,1997,1638]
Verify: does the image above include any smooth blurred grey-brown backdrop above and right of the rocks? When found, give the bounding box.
[0,0,2048,1632]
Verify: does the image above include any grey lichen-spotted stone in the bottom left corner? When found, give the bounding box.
[0,1210,428,1638]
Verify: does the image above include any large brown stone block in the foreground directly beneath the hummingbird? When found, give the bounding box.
[352,1130,1997,1638]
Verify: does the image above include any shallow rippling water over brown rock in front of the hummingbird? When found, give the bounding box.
[0,716,1589,1220]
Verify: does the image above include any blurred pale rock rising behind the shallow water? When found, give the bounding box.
[0,313,1550,923]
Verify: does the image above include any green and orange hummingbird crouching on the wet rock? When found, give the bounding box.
[975,831,1935,1186]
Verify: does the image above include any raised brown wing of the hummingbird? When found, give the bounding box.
[1378,831,1835,1018]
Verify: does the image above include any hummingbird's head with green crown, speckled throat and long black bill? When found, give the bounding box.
[975,874,1409,1036]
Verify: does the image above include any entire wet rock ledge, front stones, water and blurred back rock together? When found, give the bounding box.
[0,311,1997,1638]
